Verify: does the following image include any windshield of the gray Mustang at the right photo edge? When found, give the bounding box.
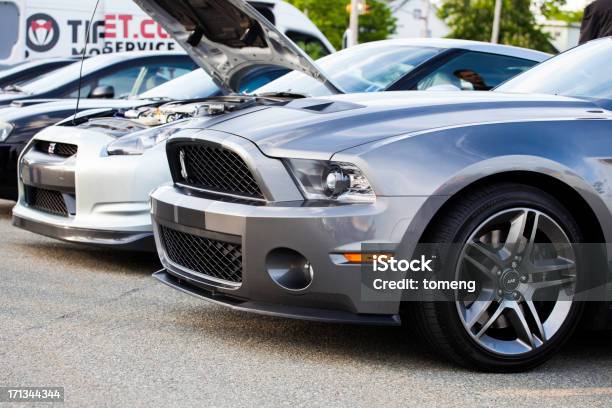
[495,38,612,100]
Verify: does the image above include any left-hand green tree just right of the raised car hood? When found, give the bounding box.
[287,0,397,49]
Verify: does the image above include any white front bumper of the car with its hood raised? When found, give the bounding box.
[13,126,171,251]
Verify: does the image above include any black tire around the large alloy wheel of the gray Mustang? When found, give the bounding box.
[404,183,584,372]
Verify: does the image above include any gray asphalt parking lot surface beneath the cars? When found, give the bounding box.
[0,201,612,407]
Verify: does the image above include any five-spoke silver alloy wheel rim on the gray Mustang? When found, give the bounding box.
[456,208,577,356]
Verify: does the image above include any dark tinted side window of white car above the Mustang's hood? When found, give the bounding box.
[417,51,537,91]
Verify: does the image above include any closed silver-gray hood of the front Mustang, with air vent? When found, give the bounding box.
[200,91,610,160]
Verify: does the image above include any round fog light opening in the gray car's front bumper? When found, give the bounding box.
[266,248,314,291]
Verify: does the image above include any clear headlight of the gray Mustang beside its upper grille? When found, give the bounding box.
[286,159,376,203]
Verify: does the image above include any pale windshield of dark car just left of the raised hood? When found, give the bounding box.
[138,68,221,100]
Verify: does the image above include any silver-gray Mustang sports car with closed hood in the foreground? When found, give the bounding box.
[152,38,612,371]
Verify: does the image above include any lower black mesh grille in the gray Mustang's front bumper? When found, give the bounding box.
[159,225,242,285]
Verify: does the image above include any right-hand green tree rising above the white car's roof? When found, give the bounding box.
[438,0,556,53]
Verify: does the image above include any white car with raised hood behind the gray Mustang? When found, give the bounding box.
[13,0,549,250]
